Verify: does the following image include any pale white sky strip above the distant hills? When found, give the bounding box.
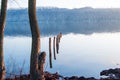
[8,0,120,9]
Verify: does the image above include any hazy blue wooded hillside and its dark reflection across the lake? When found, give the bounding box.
[5,8,120,36]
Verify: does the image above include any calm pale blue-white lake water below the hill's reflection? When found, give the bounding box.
[4,33,120,77]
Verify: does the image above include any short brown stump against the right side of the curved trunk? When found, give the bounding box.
[38,52,46,80]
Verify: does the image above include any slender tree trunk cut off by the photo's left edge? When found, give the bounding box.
[0,0,8,80]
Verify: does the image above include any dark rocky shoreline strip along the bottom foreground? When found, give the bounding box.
[5,68,120,80]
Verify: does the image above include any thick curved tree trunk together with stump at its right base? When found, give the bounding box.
[28,0,45,80]
